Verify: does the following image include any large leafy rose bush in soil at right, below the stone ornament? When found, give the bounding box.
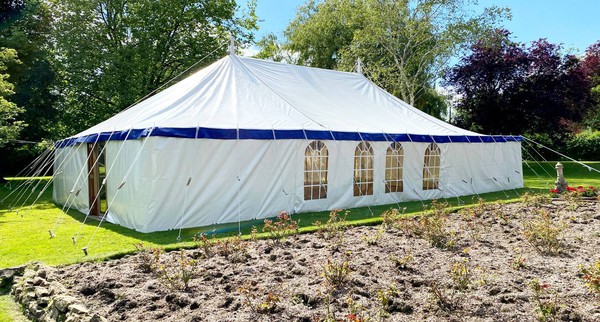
[523,210,567,255]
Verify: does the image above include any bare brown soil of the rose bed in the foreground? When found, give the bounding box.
[54,202,600,321]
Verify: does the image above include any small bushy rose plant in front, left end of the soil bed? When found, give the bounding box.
[158,251,198,290]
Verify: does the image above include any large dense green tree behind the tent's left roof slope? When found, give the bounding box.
[52,0,256,132]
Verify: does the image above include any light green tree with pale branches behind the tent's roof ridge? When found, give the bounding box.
[274,0,508,116]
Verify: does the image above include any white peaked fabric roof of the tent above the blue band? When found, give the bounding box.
[74,56,479,137]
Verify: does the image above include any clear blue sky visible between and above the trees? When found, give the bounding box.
[238,0,600,54]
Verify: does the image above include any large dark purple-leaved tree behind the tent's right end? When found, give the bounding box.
[446,31,590,141]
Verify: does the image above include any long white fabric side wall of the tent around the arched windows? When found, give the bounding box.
[71,137,523,232]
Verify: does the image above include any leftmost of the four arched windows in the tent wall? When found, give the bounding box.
[304,141,329,200]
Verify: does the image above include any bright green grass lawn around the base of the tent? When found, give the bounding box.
[0,162,600,322]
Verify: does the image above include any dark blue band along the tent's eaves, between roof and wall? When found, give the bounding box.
[56,127,523,148]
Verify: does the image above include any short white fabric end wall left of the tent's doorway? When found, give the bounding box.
[52,144,89,213]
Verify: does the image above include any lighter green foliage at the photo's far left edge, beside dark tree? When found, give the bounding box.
[0,48,25,147]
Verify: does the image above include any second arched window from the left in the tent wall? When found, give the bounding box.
[354,142,373,196]
